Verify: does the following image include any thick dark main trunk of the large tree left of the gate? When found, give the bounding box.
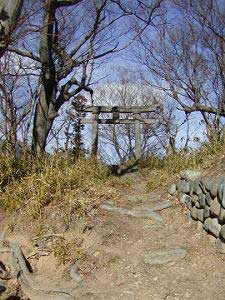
[32,0,56,153]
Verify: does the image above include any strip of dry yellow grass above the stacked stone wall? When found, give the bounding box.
[141,140,225,191]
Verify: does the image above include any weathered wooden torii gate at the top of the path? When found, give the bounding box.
[76,104,159,159]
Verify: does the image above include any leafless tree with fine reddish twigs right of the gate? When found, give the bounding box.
[134,0,225,141]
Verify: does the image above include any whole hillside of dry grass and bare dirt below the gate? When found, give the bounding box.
[0,139,225,300]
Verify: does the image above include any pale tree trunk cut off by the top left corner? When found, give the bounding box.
[0,0,23,58]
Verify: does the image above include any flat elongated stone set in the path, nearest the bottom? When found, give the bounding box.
[144,249,187,265]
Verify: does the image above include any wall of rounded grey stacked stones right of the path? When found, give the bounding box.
[169,171,225,253]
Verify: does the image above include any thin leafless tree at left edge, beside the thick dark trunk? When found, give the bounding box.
[0,54,35,151]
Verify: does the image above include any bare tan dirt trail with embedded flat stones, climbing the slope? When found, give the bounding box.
[0,173,225,300]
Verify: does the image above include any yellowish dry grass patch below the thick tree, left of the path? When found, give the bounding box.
[0,155,108,218]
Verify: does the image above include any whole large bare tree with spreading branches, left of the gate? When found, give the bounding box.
[4,0,163,153]
